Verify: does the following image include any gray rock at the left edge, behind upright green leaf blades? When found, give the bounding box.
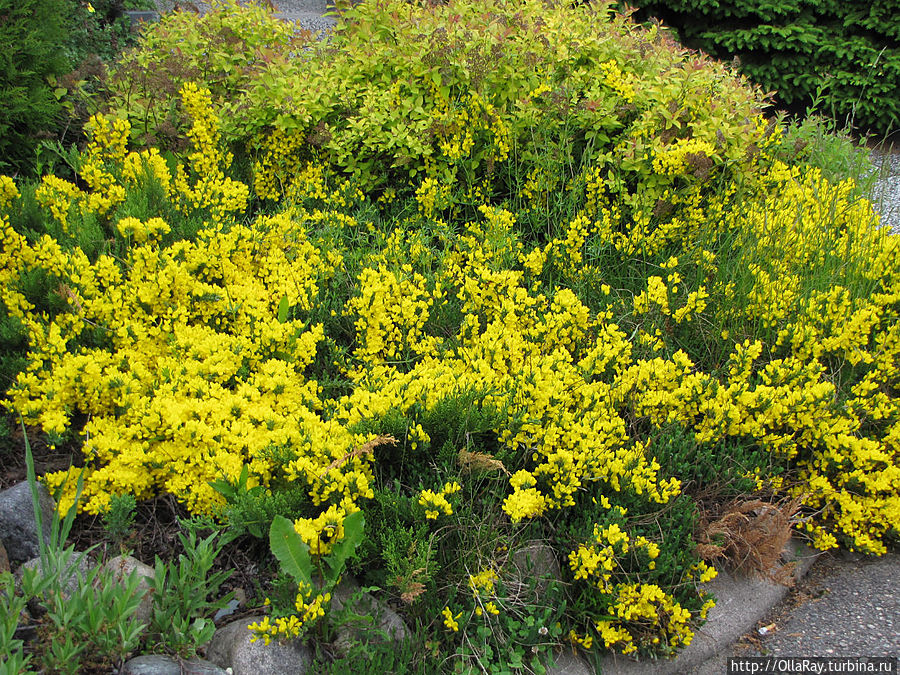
[0,482,58,565]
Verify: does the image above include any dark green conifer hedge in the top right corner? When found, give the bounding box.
[634,0,900,134]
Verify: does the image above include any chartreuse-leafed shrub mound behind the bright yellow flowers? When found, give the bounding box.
[111,0,759,211]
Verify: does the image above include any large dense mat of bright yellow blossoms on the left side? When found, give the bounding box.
[2,125,348,513]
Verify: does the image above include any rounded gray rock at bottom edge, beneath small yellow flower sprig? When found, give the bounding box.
[206,616,312,675]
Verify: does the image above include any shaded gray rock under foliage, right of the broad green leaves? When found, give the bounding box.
[331,575,409,654]
